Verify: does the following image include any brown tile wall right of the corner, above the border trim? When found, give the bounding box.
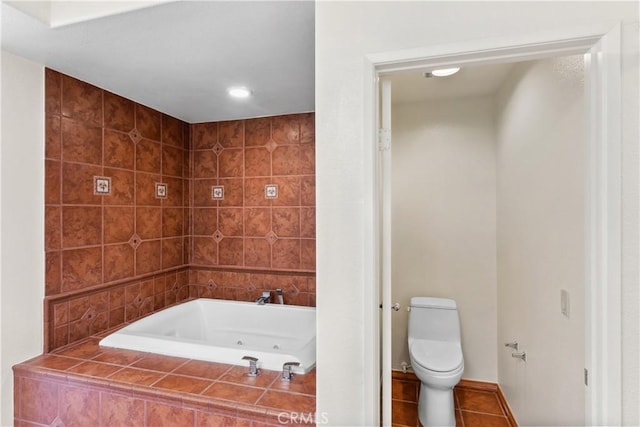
[191,113,315,272]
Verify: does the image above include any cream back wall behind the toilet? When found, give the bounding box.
[391,96,498,382]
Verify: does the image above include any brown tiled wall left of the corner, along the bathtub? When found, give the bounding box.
[45,69,189,351]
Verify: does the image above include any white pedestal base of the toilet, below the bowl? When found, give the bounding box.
[418,383,456,427]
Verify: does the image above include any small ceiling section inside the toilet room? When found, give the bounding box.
[388,63,514,104]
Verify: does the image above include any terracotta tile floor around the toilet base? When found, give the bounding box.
[392,373,517,427]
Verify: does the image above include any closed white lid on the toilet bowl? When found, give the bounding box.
[409,340,462,372]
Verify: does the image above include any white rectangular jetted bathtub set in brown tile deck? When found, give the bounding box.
[100,298,316,374]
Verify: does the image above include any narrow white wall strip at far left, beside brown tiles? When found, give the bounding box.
[0,51,44,426]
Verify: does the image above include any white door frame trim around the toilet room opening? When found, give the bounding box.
[369,29,620,425]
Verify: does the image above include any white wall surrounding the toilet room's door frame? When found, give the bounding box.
[315,1,640,425]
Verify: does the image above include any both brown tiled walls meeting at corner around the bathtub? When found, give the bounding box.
[44,69,315,352]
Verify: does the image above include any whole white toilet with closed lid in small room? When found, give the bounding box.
[408,297,464,427]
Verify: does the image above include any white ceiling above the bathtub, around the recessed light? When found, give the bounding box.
[2,1,315,123]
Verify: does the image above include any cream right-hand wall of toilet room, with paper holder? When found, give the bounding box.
[496,55,588,425]
